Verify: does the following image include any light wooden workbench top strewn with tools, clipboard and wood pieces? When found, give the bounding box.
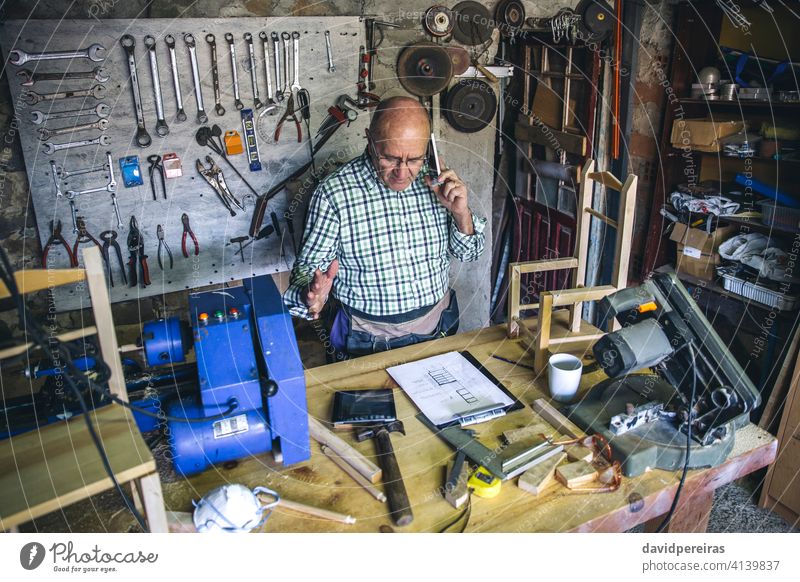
[184,312,777,532]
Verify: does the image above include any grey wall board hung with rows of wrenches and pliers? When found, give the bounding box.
[0,17,369,311]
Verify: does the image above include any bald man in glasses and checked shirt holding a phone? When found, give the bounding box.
[284,97,486,359]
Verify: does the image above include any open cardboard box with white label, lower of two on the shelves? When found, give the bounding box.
[669,222,737,281]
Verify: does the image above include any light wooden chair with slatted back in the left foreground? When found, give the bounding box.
[0,247,169,533]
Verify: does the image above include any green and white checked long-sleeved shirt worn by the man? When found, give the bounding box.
[284,151,486,318]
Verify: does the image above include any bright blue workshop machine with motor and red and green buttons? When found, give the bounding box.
[143,275,311,475]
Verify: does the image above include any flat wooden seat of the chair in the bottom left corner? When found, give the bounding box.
[0,404,156,529]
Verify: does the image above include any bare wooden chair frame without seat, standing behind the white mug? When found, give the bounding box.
[508,160,638,372]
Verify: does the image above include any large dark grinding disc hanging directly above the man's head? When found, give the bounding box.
[397,42,453,97]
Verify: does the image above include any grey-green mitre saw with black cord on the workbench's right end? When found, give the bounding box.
[567,273,761,477]
